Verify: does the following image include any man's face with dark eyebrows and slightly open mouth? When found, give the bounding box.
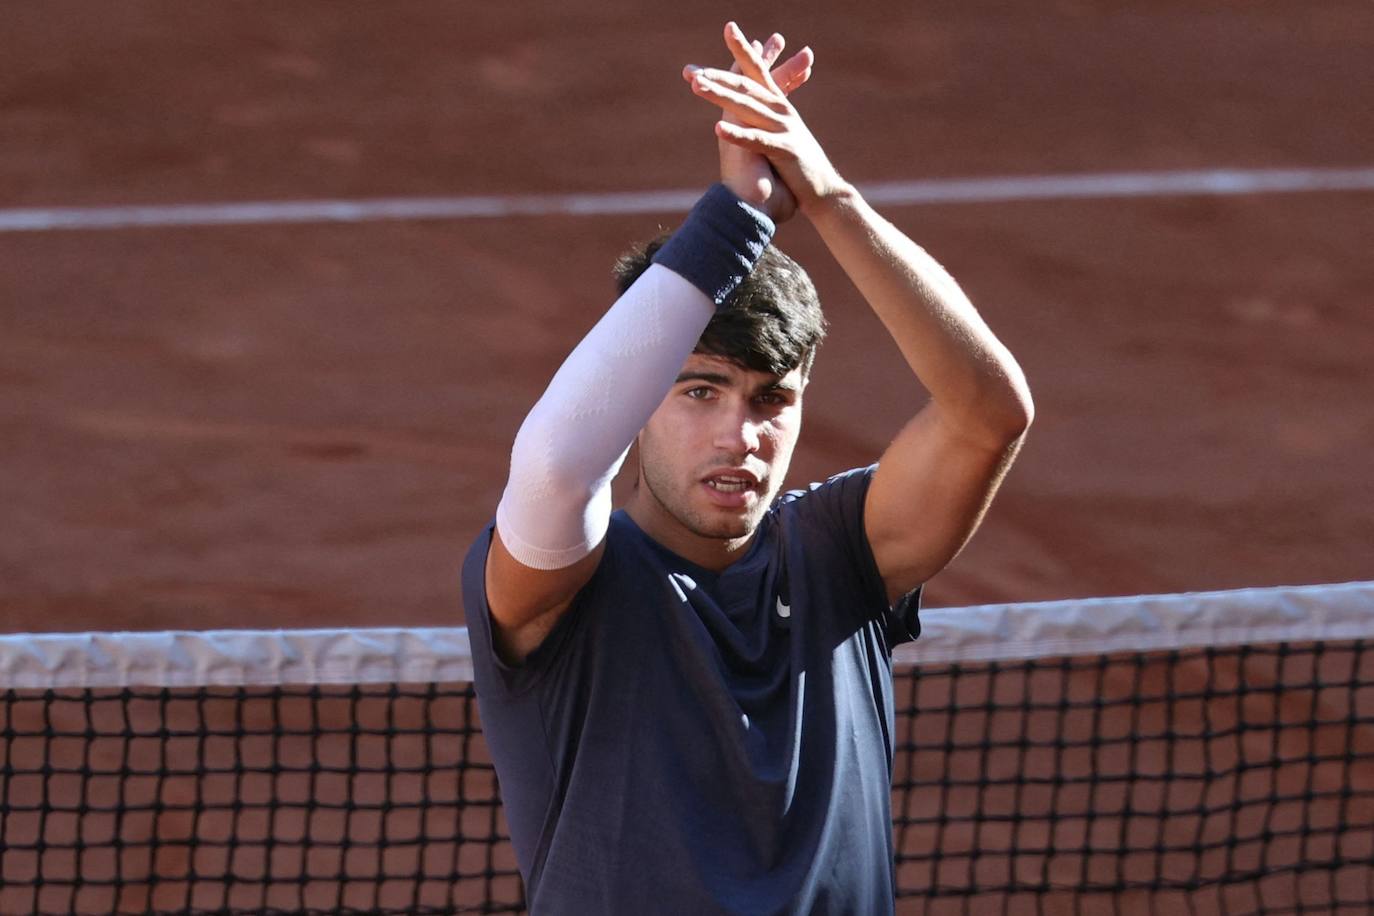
[639,353,805,549]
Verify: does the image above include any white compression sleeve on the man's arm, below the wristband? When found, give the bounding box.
[496,264,716,570]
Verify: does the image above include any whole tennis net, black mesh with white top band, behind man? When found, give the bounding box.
[0,582,1374,915]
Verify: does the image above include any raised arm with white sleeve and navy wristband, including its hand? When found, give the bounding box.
[486,34,811,662]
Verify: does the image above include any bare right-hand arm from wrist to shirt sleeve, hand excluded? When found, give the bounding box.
[804,192,1035,600]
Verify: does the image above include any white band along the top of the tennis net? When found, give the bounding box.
[0,581,1374,689]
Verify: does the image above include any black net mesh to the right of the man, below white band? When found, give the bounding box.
[893,641,1374,915]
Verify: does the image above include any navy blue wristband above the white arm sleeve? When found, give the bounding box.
[654,184,775,306]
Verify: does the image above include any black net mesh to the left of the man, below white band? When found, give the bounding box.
[0,684,523,913]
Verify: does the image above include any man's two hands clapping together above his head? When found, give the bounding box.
[683,22,844,222]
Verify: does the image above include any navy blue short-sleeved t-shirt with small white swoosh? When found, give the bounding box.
[463,467,919,916]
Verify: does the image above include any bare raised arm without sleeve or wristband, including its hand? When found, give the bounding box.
[684,23,1033,599]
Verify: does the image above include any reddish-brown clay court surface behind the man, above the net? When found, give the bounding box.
[0,0,1374,632]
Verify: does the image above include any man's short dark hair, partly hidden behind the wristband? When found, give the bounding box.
[616,233,826,378]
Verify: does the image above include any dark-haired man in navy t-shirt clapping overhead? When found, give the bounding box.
[463,23,1032,916]
